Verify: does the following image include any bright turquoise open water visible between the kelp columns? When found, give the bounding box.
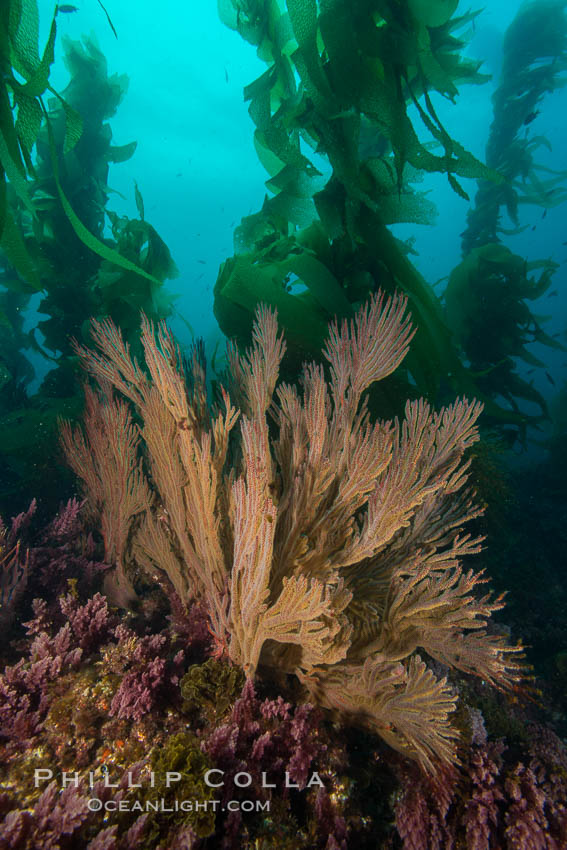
[33,2,567,404]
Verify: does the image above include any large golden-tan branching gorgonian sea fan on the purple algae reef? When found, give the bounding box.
[62,294,521,770]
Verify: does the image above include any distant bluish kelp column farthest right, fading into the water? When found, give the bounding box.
[454,0,567,423]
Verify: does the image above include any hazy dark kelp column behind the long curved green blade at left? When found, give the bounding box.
[33,38,178,370]
